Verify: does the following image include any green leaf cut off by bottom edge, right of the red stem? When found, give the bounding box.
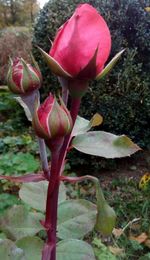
[57,239,95,260]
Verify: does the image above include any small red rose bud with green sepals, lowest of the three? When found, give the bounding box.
[33,94,72,140]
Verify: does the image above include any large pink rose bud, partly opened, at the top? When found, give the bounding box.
[49,4,111,80]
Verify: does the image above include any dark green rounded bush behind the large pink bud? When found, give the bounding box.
[33,0,150,169]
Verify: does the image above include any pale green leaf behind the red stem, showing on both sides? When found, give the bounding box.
[19,181,66,212]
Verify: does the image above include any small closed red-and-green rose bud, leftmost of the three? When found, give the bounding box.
[7,58,42,94]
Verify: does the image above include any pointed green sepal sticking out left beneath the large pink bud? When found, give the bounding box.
[37,46,72,78]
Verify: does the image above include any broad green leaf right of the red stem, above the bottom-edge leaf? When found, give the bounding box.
[58,200,96,239]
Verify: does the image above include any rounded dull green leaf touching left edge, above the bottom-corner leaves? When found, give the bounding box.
[0,205,44,240]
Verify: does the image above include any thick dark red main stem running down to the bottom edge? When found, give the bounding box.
[42,96,81,260]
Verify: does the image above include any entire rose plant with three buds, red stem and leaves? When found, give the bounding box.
[0,4,140,260]
